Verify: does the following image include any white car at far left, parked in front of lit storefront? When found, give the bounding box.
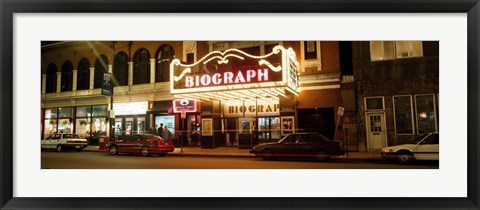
[41,133,88,152]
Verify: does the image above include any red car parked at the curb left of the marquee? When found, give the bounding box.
[105,134,175,156]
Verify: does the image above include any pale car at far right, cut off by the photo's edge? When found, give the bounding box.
[380,133,439,164]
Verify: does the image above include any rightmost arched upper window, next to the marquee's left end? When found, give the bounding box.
[155,45,175,82]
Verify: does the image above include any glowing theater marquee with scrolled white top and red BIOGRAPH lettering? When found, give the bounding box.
[170,45,299,101]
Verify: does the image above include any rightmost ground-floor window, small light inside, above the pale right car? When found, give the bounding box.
[415,94,437,134]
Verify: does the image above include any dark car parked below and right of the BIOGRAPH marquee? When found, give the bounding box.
[250,133,344,161]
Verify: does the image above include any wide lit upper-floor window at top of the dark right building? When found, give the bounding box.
[370,41,423,61]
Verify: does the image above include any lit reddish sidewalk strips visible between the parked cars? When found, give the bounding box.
[84,145,382,160]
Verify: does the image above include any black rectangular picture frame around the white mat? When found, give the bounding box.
[0,0,480,209]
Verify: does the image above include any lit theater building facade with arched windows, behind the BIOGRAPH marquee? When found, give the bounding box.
[41,41,343,148]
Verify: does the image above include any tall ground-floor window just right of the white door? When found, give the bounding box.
[393,96,413,134]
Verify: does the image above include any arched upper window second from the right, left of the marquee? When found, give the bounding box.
[133,48,150,85]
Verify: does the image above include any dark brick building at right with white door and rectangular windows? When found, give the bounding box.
[346,41,439,151]
